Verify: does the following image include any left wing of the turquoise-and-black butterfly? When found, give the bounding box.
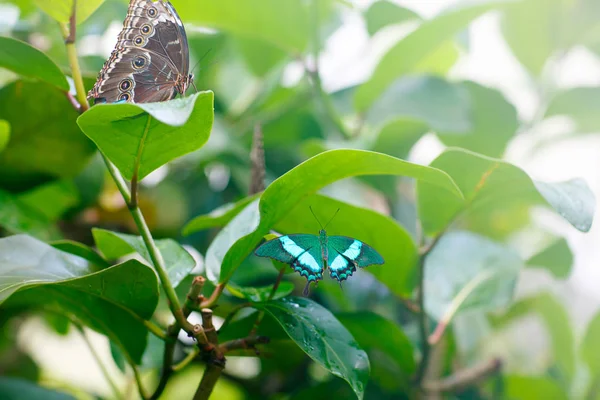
[254,234,324,282]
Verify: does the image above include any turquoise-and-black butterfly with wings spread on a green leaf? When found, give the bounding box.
[254,208,384,295]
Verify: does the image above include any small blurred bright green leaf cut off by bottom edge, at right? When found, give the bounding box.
[503,375,569,400]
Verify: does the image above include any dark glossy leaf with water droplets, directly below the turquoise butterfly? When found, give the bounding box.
[255,297,369,399]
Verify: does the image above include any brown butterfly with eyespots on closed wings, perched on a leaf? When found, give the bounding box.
[88,0,193,104]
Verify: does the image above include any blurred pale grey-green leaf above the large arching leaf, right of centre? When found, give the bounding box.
[367,76,472,133]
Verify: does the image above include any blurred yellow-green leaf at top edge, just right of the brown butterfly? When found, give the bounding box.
[173,0,310,53]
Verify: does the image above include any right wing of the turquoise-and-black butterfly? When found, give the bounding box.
[327,236,384,282]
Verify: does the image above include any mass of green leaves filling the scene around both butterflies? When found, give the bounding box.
[0,0,600,400]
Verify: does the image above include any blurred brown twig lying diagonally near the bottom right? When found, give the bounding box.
[422,358,502,393]
